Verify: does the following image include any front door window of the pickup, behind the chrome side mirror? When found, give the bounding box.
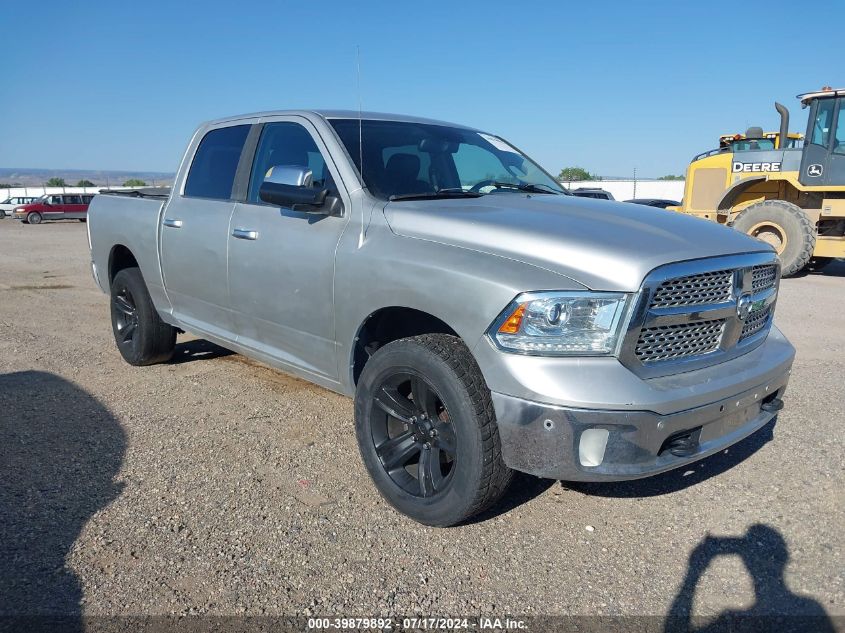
[247,121,335,204]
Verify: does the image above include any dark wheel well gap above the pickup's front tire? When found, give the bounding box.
[352,306,457,384]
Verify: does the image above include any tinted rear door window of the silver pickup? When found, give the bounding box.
[185,125,250,200]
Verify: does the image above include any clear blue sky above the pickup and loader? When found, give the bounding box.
[0,0,845,177]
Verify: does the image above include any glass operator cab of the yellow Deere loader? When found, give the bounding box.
[798,88,845,187]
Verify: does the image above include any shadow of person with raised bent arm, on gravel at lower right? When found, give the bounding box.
[664,524,835,633]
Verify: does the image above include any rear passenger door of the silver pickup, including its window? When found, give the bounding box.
[159,124,251,339]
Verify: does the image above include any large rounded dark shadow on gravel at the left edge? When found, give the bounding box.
[0,371,126,631]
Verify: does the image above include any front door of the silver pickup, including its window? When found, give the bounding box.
[229,116,348,380]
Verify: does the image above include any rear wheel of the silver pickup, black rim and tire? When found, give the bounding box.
[110,268,176,366]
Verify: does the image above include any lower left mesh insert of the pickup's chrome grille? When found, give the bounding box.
[636,319,725,363]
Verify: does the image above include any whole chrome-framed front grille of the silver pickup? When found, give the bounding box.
[619,253,780,377]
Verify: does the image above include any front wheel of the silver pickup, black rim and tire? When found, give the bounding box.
[355,334,513,527]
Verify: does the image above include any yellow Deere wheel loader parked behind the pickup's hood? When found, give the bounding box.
[669,88,845,275]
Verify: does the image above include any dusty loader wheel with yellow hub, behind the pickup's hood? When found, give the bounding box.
[733,200,816,277]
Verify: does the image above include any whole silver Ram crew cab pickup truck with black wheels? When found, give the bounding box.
[88,111,794,526]
